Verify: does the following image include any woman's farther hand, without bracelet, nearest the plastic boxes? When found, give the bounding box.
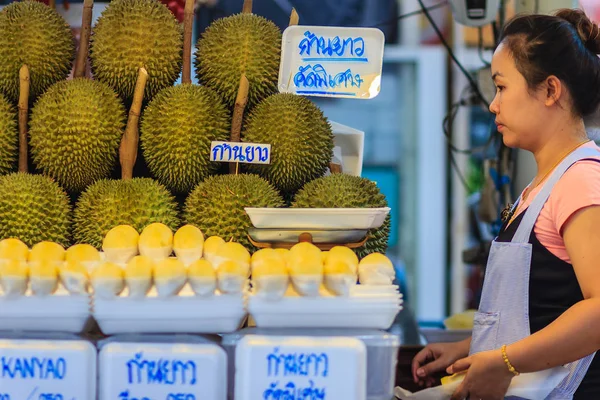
[412,338,471,387]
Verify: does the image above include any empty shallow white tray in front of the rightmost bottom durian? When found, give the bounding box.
[244,207,390,230]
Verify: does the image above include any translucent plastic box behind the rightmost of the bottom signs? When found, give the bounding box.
[221,328,400,400]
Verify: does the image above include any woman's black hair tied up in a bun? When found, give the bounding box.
[500,9,600,117]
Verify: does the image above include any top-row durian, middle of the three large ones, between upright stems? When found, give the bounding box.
[90,0,183,101]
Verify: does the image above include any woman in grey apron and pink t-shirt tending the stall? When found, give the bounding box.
[412,10,600,400]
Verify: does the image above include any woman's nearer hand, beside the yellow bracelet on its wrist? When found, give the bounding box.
[447,350,514,400]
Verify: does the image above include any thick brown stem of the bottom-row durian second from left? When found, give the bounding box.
[119,67,148,179]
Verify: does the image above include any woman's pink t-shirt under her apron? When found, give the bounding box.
[508,141,600,264]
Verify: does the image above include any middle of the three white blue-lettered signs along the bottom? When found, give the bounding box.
[99,343,227,400]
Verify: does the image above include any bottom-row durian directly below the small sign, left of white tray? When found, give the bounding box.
[184,174,284,250]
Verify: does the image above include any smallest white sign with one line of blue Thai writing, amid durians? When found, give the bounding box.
[210,141,271,164]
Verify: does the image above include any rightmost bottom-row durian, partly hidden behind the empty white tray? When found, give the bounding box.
[292,174,391,258]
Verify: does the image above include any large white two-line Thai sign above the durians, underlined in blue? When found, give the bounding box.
[279,25,385,99]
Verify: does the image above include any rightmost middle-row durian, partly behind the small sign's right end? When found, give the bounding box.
[242,93,333,196]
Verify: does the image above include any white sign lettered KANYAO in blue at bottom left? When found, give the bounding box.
[0,340,96,400]
